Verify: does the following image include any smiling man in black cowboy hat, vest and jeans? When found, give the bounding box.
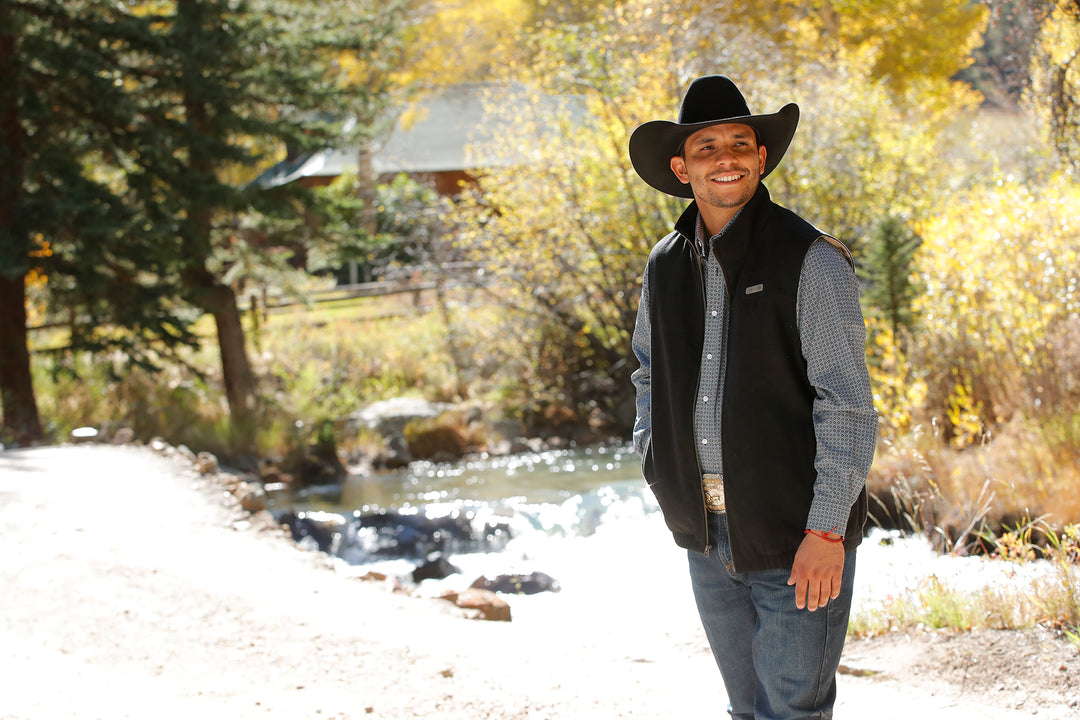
[630,76,877,720]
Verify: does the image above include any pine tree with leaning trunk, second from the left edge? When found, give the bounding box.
[121,0,400,450]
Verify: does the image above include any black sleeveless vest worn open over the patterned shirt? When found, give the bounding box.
[643,186,866,572]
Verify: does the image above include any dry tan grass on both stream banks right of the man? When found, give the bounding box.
[850,418,1080,647]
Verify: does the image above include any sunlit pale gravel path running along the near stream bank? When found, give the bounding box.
[0,445,1080,720]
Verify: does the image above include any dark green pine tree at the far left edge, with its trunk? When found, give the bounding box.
[0,0,192,443]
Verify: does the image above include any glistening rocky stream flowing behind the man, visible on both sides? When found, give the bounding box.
[269,445,1067,624]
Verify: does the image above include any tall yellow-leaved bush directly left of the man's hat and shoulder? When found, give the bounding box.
[440,2,684,411]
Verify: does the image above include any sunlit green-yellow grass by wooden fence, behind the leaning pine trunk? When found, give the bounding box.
[33,284,514,456]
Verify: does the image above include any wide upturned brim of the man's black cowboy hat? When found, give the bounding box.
[630,103,799,198]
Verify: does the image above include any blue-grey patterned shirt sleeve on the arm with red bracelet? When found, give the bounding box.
[796,240,878,534]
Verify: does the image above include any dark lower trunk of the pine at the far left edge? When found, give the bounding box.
[0,273,43,444]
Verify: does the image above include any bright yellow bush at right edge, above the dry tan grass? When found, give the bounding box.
[916,174,1080,431]
